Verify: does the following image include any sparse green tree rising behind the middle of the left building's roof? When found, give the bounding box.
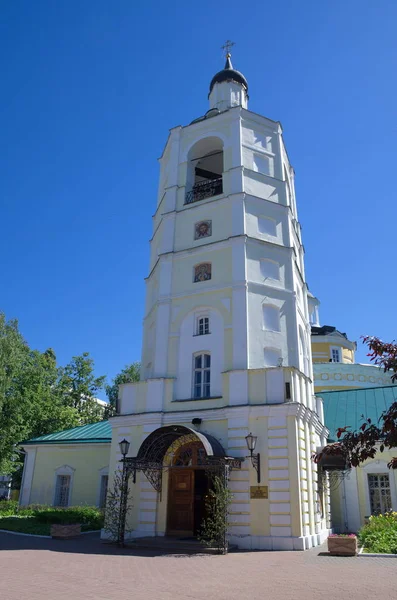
[56,352,106,425]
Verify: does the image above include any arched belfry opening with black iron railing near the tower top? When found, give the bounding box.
[186,137,224,204]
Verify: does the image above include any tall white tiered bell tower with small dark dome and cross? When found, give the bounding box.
[119,52,327,549]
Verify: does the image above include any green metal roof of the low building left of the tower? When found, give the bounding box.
[21,421,112,446]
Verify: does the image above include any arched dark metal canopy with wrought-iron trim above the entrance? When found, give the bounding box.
[123,425,242,492]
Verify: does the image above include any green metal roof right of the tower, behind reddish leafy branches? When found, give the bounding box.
[316,385,397,440]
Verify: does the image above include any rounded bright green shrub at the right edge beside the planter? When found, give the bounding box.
[359,512,397,554]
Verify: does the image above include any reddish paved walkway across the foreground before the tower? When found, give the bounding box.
[0,533,397,600]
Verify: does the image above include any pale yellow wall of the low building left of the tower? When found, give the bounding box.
[29,444,110,506]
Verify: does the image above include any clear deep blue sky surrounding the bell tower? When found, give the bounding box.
[0,0,397,392]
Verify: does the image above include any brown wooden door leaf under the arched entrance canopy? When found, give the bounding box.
[167,468,194,535]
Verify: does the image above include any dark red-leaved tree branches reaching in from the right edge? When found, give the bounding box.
[314,336,397,469]
